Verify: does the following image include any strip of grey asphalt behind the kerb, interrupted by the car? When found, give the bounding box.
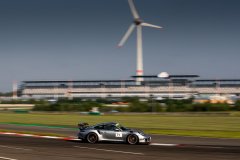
[0,124,240,147]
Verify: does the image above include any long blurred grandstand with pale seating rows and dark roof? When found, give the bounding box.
[21,74,240,99]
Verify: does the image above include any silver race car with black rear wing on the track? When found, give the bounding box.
[77,122,151,144]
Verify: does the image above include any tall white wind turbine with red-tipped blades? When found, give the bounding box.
[117,0,163,85]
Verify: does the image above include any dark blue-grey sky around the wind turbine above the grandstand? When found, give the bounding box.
[0,0,240,92]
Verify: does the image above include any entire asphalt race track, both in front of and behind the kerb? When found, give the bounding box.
[0,124,240,160]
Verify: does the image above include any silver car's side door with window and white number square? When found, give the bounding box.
[104,124,123,141]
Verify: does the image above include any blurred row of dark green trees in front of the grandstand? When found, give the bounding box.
[33,97,240,112]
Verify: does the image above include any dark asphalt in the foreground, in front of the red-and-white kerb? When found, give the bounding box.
[0,135,240,160]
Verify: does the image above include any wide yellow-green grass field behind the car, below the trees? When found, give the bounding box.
[0,113,240,138]
